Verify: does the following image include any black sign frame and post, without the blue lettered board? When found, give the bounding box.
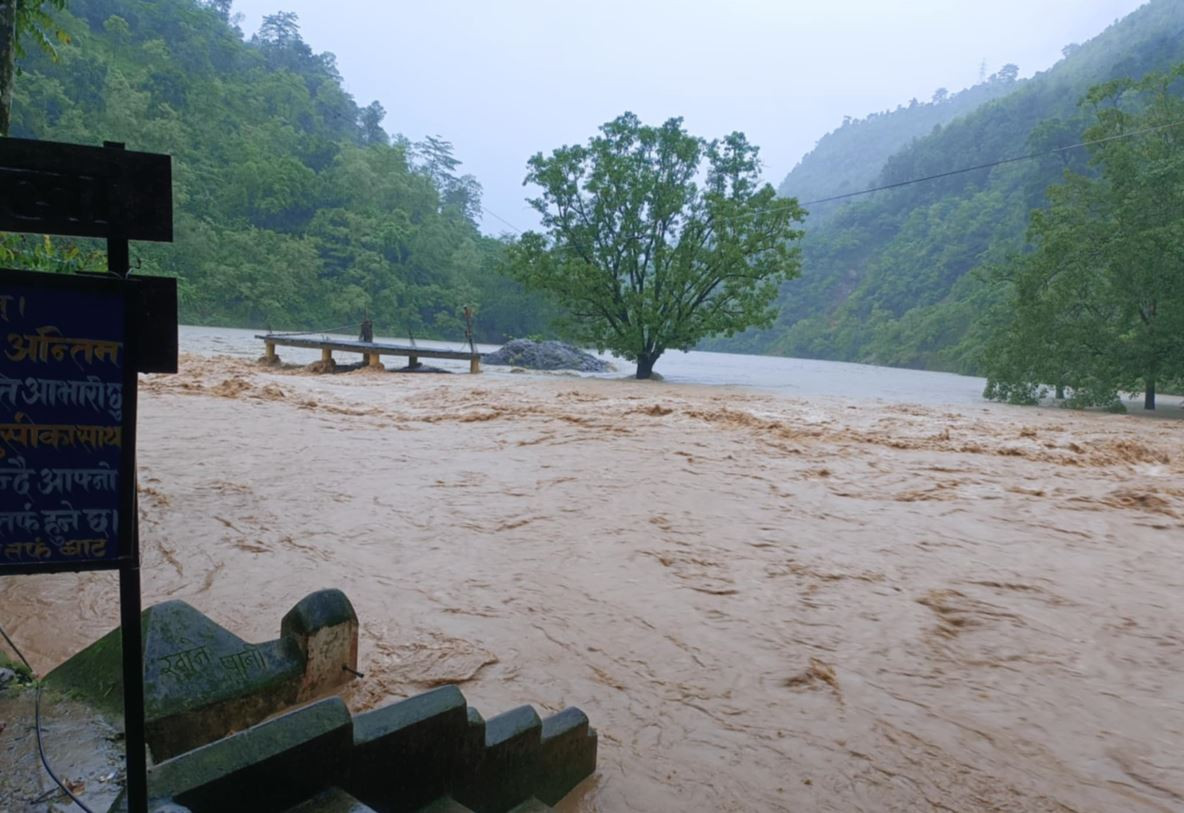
[0,137,176,813]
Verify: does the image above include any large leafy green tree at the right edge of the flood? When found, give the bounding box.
[986,65,1184,409]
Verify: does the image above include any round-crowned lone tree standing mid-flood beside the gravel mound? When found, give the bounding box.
[507,114,805,379]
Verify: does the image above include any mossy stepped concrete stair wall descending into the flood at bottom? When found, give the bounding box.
[111,686,597,813]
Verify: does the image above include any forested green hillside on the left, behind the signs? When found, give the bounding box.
[4,0,546,341]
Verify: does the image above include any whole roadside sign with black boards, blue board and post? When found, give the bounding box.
[0,138,176,813]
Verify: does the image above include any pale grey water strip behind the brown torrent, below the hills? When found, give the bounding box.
[181,325,985,405]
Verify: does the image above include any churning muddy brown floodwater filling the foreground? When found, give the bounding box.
[0,356,1184,813]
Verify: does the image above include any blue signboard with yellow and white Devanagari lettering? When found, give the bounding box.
[0,271,135,573]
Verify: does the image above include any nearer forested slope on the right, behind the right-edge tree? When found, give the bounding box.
[726,0,1184,372]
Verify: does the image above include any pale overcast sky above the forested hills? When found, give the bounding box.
[234,0,1144,233]
